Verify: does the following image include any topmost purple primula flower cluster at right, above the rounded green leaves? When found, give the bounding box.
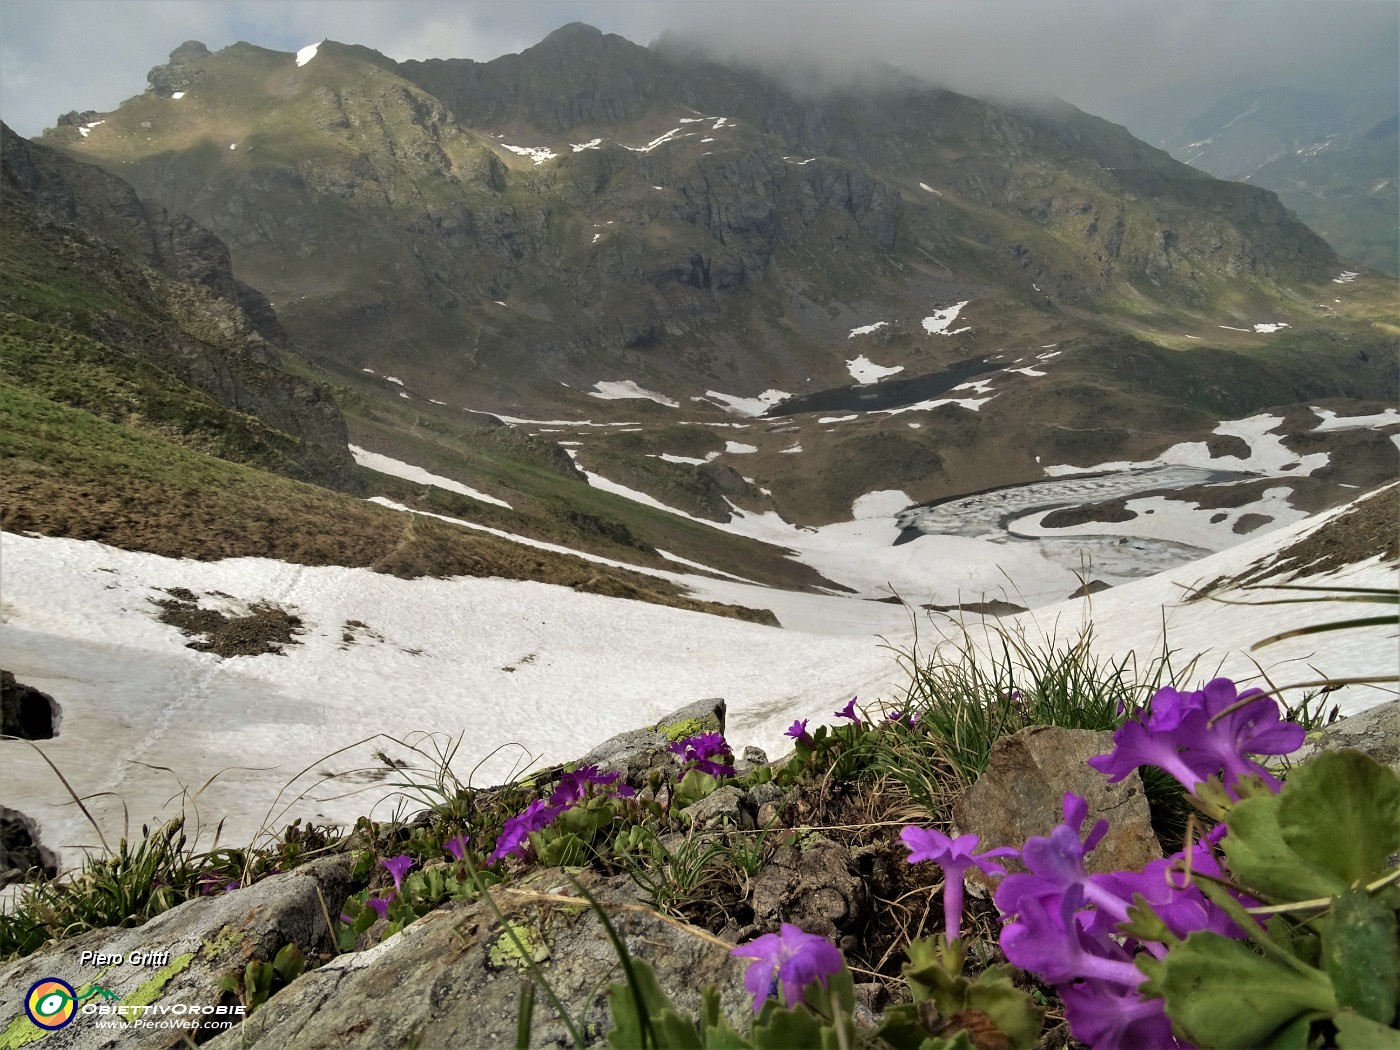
[1089,678,1303,795]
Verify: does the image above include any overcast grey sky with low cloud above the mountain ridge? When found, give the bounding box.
[0,0,1400,144]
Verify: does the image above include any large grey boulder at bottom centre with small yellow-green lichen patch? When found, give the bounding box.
[209,869,752,1050]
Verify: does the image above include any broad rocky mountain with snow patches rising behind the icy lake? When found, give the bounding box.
[13,25,1397,578]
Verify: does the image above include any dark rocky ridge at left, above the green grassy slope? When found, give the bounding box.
[0,126,353,484]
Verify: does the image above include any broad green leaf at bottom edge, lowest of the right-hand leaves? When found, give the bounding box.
[1138,931,1337,1050]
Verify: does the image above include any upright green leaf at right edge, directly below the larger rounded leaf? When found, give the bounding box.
[1323,889,1400,1025]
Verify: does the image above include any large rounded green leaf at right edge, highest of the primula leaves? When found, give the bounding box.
[1282,750,1400,896]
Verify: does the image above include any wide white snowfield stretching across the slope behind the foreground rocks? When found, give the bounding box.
[0,487,1397,879]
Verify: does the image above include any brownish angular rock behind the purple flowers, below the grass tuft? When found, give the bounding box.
[953,725,1162,882]
